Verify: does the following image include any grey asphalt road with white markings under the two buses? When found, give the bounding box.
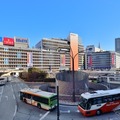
[0,78,120,120]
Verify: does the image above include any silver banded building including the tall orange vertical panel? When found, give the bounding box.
[35,33,84,71]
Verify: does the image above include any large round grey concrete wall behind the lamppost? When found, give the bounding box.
[56,71,88,95]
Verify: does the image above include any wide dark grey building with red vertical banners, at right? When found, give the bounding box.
[85,51,120,70]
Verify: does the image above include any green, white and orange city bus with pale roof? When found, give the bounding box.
[20,88,57,110]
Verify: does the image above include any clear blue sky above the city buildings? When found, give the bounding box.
[0,0,120,50]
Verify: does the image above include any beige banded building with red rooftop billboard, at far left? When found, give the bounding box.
[0,37,41,69]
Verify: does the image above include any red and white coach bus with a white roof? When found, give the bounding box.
[78,88,120,116]
